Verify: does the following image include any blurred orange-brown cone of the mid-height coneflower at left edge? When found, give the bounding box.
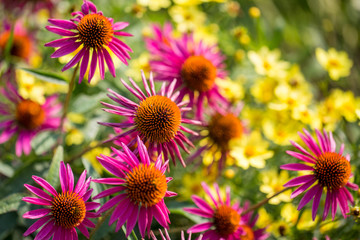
[15,100,45,130]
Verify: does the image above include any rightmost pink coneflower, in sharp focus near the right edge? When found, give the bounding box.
[280,129,359,220]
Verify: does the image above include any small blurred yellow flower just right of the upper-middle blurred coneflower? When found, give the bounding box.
[215,78,245,103]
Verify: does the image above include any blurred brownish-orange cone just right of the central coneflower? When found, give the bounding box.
[208,113,243,150]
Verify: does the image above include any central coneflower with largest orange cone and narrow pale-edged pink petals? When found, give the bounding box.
[100,72,200,166]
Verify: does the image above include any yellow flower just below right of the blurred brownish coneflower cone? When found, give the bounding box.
[230,131,274,169]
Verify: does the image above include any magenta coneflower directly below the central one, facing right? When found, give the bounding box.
[93,137,176,237]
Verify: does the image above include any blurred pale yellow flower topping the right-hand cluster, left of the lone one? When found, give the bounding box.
[248,47,289,78]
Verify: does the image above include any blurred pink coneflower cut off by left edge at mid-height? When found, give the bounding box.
[0,82,61,156]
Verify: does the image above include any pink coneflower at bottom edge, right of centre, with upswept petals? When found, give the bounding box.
[184,182,243,240]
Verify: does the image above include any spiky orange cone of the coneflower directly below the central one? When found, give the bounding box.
[126,164,167,207]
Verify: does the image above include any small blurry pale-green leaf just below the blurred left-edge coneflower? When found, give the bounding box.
[31,131,59,155]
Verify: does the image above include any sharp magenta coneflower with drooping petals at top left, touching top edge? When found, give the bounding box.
[45,0,132,82]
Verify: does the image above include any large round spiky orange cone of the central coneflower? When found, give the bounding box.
[134,95,181,143]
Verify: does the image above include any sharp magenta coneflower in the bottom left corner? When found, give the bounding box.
[22,162,100,239]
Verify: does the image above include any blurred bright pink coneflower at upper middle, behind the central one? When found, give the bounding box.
[146,24,228,119]
